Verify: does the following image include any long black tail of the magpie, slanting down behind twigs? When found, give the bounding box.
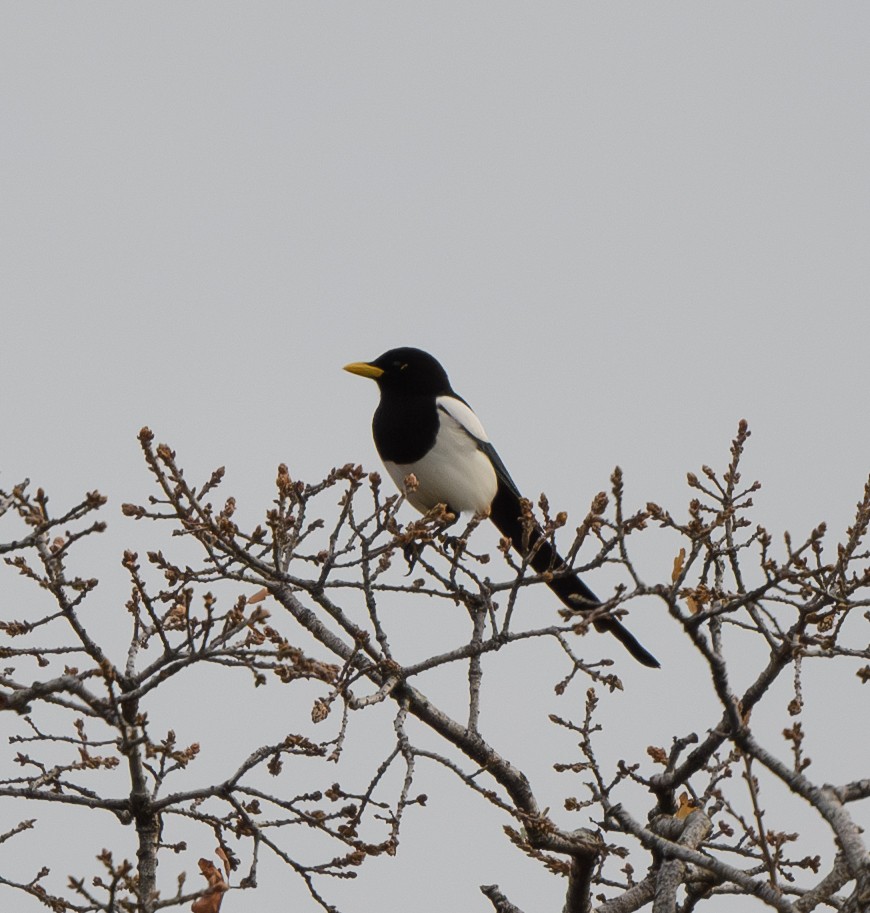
[489,478,659,669]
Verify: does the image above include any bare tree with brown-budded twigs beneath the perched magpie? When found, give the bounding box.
[0,423,870,913]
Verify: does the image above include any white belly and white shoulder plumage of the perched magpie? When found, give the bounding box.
[384,396,498,513]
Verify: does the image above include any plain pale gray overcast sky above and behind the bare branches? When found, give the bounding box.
[0,2,870,909]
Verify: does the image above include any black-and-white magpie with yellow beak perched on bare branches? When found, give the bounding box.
[344,347,659,668]
